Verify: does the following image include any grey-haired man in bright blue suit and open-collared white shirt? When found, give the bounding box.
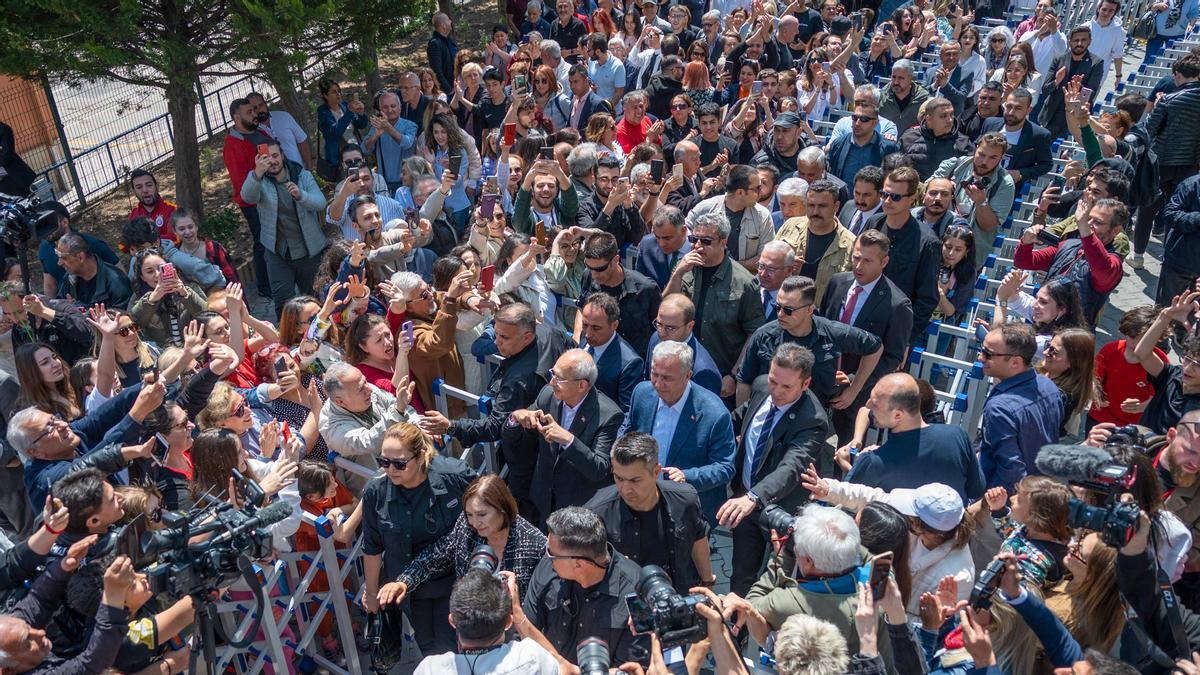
[619,342,733,524]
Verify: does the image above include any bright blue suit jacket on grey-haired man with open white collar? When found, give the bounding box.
[618,382,734,522]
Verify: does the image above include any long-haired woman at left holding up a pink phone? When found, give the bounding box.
[130,249,206,348]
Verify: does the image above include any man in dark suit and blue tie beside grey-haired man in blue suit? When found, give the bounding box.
[716,342,829,596]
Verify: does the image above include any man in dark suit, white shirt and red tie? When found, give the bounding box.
[821,229,913,441]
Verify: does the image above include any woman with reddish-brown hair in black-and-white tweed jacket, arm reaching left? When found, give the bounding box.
[379,474,546,604]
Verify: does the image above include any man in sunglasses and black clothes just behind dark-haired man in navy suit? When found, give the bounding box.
[575,232,662,354]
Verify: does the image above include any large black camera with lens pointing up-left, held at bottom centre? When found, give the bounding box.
[625,565,708,650]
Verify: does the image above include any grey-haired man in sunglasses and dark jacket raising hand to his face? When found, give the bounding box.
[664,210,769,389]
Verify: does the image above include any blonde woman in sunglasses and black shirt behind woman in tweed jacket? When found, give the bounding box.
[362,422,472,653]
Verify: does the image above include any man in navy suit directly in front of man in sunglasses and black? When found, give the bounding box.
[580,292,646,413]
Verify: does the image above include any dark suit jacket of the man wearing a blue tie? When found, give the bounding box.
[730,389,829,513]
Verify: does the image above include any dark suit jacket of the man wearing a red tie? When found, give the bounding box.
[821,271,912,384]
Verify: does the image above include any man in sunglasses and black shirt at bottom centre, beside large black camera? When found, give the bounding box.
[521,507,649,663]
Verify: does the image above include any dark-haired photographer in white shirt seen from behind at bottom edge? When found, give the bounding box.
[414,569,560,675]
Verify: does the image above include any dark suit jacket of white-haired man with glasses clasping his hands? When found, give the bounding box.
[526,384,625,524]
